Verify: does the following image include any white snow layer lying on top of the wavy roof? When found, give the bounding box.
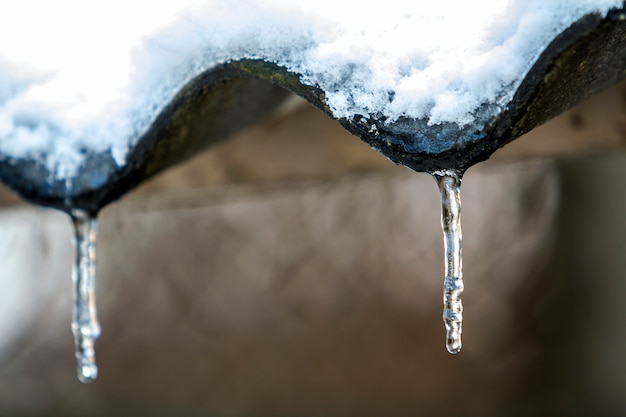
[0,0,622,179]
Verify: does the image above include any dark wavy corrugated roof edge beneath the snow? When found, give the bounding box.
[0,3,626,213]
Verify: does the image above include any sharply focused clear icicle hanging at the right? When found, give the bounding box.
[432,170,463,354]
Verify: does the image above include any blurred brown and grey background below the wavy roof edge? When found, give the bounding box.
[0,79,626,417]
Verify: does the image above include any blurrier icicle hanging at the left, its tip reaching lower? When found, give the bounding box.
[71,210,100,383]
